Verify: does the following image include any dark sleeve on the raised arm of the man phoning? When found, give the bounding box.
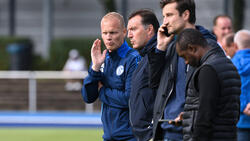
[148,49,166,89]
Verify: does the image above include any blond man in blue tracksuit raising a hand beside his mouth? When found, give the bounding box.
[82,12,140,141]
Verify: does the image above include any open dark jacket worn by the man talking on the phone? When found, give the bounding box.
[148,26,219,140]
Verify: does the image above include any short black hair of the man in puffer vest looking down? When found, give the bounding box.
[176,28,208,50]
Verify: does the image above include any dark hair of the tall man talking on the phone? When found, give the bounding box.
[160,0,196,24]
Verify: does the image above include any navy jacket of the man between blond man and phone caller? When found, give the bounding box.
[129,35,157,141]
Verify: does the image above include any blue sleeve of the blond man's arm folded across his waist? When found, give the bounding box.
[100,58,139,108]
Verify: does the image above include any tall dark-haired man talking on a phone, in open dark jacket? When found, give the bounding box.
[148,0,222,141]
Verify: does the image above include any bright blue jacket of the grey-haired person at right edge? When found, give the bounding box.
[232,49,250,129]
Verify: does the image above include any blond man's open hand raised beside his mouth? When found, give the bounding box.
[91,39,107,71]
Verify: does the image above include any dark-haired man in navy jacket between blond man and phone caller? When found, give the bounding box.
[127,9,159,141]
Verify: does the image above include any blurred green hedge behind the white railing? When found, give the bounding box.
[0,37,133,70]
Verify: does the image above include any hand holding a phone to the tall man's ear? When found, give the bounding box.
[157,24,174,51]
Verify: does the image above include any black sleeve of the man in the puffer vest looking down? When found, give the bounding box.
[194,66,220,141]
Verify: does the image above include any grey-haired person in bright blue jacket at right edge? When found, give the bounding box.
[232,30,250,141]
